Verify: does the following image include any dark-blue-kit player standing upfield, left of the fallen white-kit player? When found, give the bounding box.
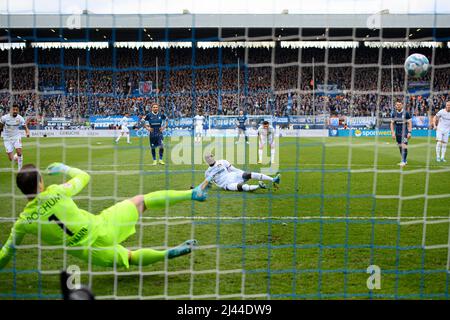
[145,103,166,166]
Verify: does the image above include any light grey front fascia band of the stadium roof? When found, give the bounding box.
[0,11,450,29]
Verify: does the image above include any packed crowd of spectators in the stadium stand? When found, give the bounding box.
[0,47,450,119]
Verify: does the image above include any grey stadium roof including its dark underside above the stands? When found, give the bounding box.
[0,11,450,42]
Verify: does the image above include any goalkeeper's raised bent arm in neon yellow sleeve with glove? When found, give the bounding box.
[47,162,91,197]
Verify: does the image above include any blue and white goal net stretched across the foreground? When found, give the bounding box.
[0,1,450,299]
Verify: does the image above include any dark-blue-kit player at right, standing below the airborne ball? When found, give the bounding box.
[391,101,412,167]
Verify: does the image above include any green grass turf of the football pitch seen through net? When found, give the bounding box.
[0,138,450,299]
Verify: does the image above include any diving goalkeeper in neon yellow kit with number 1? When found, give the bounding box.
[0,163,209,269]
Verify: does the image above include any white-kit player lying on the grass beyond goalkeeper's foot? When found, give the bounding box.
[205,154,280,191]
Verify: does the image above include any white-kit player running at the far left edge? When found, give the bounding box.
[0,105,30,170]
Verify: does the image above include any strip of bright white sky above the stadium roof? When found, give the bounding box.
[0,0,450,15]
